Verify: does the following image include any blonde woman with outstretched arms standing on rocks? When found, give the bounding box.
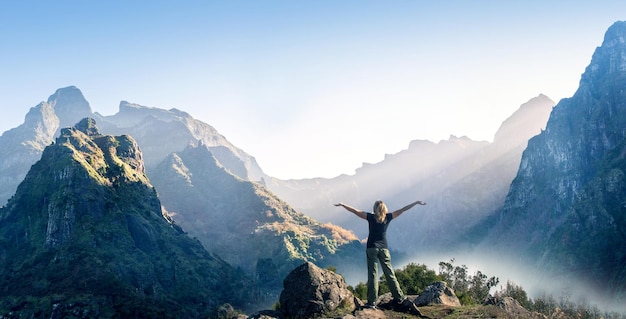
[335,200,426,308]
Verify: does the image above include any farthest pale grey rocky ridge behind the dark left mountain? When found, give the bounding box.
[0,86,266,205]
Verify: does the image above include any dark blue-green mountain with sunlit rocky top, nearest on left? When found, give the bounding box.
[0,119,250,318]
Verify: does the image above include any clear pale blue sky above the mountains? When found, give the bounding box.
[0,0,626,178]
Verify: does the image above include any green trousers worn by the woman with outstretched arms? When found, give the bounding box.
[366,248,404,305]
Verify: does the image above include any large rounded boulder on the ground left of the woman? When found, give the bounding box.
[280,262,356,318]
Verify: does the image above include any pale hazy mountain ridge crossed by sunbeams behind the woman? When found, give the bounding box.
[267,95,554,252]
